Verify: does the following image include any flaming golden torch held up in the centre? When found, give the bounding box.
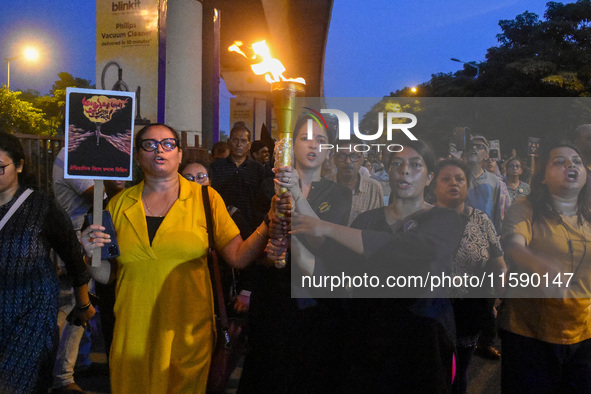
[228,41,306,268]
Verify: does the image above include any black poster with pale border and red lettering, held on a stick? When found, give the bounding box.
[64,88,135,180]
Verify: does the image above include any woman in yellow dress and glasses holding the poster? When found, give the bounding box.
[82,124,282,394]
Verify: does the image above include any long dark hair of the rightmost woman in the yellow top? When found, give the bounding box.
[527,142,591,224]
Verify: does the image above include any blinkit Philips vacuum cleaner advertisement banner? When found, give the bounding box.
[96,0,159,125]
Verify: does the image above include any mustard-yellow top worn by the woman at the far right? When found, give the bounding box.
[499,199,591,345]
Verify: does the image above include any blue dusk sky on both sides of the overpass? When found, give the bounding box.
[0,0,546,114]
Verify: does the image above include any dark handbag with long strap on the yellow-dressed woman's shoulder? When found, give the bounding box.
[201,186,246,393]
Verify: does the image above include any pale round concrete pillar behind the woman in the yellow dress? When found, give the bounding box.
[165,0,203,145]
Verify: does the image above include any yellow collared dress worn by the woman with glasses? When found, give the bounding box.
[107,175,239,394]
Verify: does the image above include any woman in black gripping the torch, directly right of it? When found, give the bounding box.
[238,116,351,394]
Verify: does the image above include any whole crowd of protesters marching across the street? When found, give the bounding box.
[0,120,591,393]
